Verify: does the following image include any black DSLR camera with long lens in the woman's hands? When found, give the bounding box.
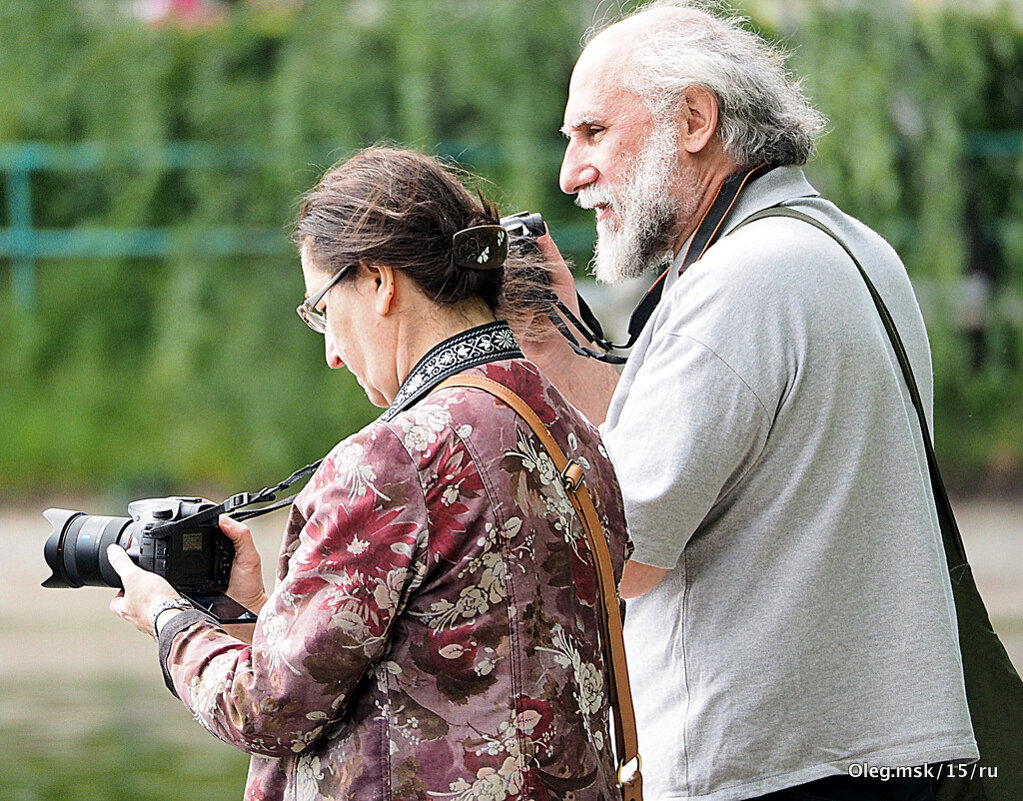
[43,497,256,623]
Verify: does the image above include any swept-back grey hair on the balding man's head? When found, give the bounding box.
[589,0,827,167]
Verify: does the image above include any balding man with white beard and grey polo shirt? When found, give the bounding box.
[530,2,977,801]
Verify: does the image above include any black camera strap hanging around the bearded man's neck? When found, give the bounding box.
[547,164,772,364]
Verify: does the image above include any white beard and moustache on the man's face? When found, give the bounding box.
[576,125,699,283]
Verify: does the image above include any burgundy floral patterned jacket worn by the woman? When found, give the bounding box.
[162,324,627,801]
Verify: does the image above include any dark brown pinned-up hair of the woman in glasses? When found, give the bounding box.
[294,147,544,316]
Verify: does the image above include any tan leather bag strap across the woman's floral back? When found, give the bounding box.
[437,375,642,801]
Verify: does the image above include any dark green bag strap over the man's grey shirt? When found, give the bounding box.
[731,206,969,572]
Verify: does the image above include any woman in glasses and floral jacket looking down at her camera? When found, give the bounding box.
[109,148,627,801]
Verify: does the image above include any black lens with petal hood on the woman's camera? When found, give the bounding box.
[43,509,138,587]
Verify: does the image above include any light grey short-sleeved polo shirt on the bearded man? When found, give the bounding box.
[602,168,977,801]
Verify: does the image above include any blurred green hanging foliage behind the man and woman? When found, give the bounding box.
[0,0,1023,501]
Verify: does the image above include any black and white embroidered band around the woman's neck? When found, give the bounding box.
[382,320,524,420]
